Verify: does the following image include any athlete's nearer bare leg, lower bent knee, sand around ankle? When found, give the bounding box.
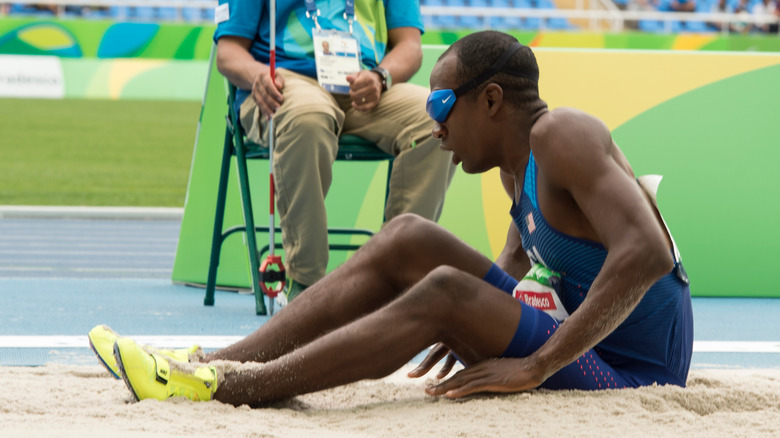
[214,266,522,406]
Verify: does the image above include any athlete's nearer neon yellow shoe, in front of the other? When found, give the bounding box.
[114,338,217,401]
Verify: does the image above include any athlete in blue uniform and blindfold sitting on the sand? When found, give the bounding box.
[95,31,693,406]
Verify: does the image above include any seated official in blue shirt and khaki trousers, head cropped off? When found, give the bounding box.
[214,0,455,299]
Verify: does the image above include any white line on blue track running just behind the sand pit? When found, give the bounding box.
[0,335,780,353]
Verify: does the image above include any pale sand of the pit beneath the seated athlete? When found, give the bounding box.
[0,365,780,438]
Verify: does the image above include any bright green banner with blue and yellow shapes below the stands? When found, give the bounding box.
[0,17,780,61]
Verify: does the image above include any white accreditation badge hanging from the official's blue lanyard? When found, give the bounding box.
[312,29,361,94]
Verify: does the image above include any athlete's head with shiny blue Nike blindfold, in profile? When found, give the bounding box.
[426,31,545,173]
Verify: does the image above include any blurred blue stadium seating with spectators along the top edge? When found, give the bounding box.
[0,0,780,33]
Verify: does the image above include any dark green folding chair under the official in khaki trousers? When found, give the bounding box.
[203,84,394,315]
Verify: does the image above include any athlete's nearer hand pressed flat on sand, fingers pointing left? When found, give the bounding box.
[425,359,544,398]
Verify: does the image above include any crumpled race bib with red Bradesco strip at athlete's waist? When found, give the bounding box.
[512,263,569,322]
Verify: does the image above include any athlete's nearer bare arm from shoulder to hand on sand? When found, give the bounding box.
[428,110,673,397]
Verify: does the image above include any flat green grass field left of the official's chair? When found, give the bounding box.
[0,99,200,207]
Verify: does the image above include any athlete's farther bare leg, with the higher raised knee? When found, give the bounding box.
[204,215,492,362]
